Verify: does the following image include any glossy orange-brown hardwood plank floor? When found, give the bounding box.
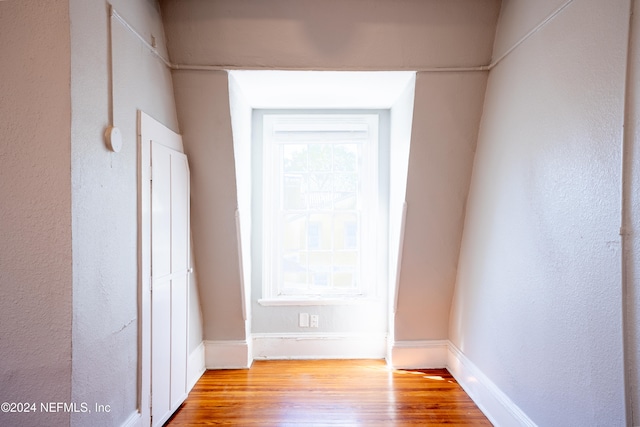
[166,360,491,427]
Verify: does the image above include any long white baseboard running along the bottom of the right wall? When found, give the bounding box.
[447,342,537,427]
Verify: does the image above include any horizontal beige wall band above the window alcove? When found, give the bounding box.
[162,0,500,70]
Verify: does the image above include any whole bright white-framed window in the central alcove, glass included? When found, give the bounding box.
[262,111,378,299]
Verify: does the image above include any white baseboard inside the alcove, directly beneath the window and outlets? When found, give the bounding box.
[253,333,387,359]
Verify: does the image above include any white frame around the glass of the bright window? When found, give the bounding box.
[260,111,380,305]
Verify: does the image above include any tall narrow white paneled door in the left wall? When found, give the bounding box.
[143,115,190,426]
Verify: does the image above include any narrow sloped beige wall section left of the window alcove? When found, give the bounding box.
[173,71,245,340]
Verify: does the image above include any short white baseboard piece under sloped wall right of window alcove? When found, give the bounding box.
[387,340,449,369]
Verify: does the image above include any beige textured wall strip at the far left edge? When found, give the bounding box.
[0,0,72,427]
